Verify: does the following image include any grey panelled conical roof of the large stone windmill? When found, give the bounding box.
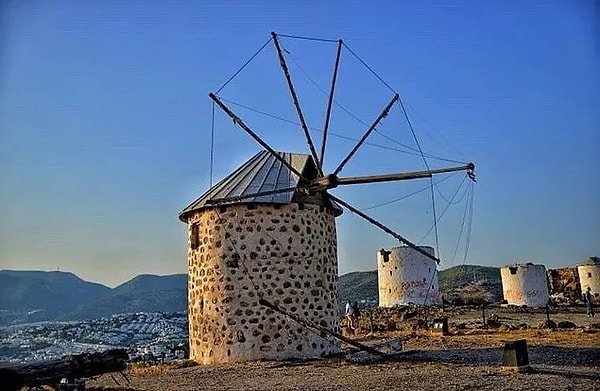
[179,151,341,222]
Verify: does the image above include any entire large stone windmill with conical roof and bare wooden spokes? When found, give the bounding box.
[179,33,474,363]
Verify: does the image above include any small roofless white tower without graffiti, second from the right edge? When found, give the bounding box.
[500,264,549,307]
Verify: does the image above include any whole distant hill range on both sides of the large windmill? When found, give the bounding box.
[0,266,502,325]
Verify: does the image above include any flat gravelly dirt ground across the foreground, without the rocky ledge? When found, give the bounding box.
[88,329,600,391]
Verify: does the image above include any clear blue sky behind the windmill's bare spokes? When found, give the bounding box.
[0,1,600,286]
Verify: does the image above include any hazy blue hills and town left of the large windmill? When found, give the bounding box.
[0,270,187,325]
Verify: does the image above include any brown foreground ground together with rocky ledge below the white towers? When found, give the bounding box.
[87,307,600,391]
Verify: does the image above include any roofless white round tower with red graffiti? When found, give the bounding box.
[377,246,439,307]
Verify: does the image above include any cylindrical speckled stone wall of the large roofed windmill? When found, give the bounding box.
[188,204,339,364]
